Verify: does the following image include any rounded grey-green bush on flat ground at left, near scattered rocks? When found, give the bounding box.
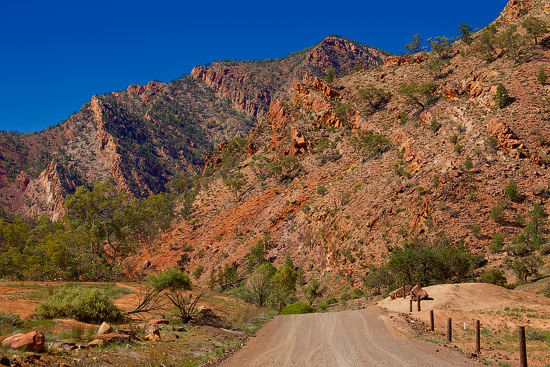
[35,285,123,323]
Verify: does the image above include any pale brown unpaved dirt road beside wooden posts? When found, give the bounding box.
[219,310,481,367]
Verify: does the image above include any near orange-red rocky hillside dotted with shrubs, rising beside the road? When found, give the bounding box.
[136,0,550,283]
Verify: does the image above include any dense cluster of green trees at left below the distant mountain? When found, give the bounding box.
[0,182,174,280]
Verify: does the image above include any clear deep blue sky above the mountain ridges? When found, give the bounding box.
[0,0,507,132]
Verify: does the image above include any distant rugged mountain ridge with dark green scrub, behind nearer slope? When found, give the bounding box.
[0,37,385,218]
